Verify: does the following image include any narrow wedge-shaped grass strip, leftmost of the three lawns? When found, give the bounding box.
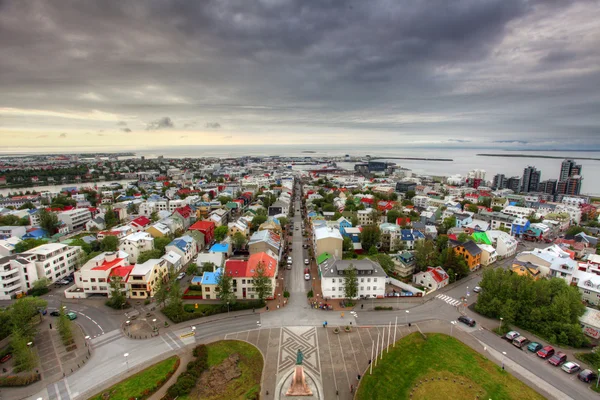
[90,356,179,400]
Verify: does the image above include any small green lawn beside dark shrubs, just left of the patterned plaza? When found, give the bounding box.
[189,340,263,400]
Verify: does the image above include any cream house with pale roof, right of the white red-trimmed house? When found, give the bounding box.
[127,259,169,299]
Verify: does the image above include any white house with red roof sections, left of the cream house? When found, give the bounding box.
[74,251,133,297]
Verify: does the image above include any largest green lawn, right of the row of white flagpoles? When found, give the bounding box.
[356,333,544,400]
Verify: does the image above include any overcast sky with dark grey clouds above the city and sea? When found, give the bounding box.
[0,0,600,150]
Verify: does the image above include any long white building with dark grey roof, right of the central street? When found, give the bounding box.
[319,256,387,299]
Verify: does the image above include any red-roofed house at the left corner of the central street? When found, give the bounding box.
[225,253,277,299]
